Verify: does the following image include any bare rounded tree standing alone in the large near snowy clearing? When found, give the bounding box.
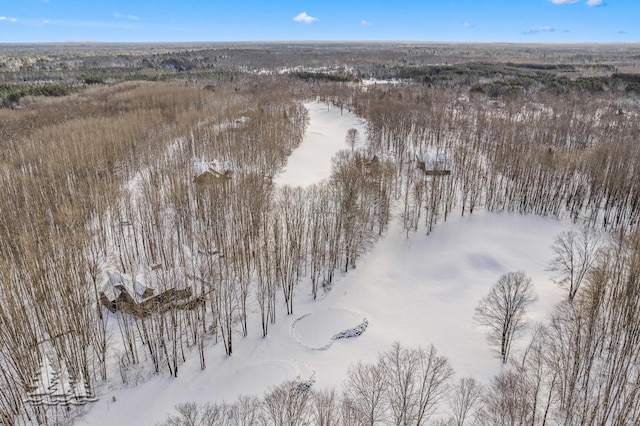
[475,271,537,364]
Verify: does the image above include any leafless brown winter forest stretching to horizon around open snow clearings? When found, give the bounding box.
[0,43,640,425]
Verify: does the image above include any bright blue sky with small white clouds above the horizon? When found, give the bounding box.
[0,0,640,43]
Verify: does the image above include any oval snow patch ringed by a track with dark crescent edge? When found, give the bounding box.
[292,309,369,351]
